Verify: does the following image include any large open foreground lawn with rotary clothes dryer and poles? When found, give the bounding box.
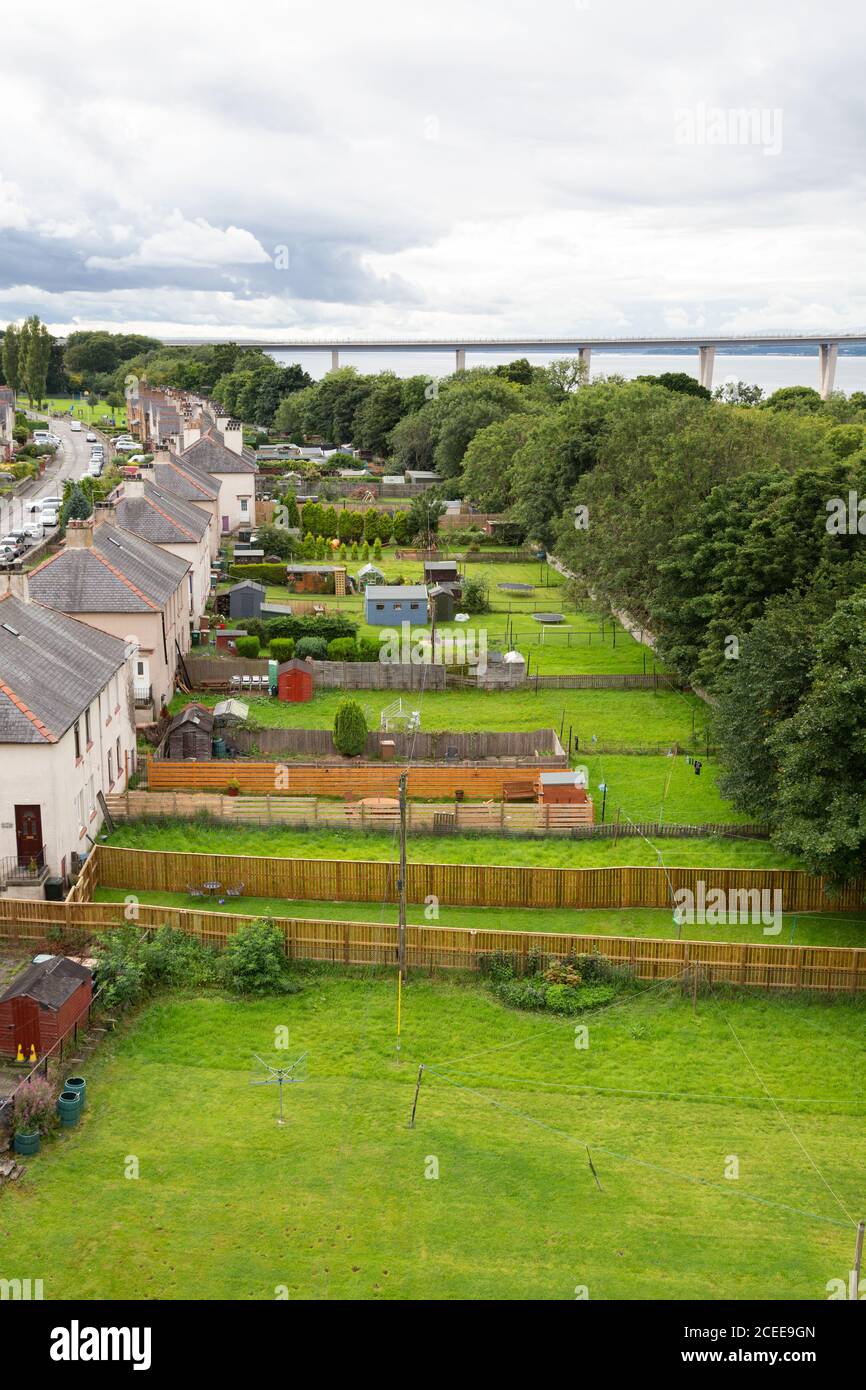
[0,972,866,1302]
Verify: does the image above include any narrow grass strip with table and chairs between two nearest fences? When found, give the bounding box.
[93,888,866,947]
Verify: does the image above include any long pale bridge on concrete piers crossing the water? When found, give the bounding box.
[159,334,866,400]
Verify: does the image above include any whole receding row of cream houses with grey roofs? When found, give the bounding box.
[0,389,262,897]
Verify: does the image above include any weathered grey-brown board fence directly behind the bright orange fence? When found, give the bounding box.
[227,728,567,767]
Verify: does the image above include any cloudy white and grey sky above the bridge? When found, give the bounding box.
[0,0,866,338]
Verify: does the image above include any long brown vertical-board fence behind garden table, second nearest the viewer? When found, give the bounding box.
[90,845,866,912]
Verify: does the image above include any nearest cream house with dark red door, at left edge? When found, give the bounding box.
[0,586,135,897]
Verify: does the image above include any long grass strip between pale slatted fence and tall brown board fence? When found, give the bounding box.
[108,820,799,869]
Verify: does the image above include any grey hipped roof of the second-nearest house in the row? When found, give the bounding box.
[29,523,189,613]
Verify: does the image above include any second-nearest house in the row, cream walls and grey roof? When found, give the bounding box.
[29,520,190,724]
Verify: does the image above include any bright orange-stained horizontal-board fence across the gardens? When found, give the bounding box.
[146,755,556,801]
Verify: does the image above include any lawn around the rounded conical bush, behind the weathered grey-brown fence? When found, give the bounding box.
[170,688,708,760]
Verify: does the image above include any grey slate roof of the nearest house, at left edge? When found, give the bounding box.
[0,594,126,744]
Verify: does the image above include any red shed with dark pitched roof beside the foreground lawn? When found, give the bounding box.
[0,956,93,1058]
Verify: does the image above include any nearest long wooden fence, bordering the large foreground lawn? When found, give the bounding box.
[0,889,866,992]
